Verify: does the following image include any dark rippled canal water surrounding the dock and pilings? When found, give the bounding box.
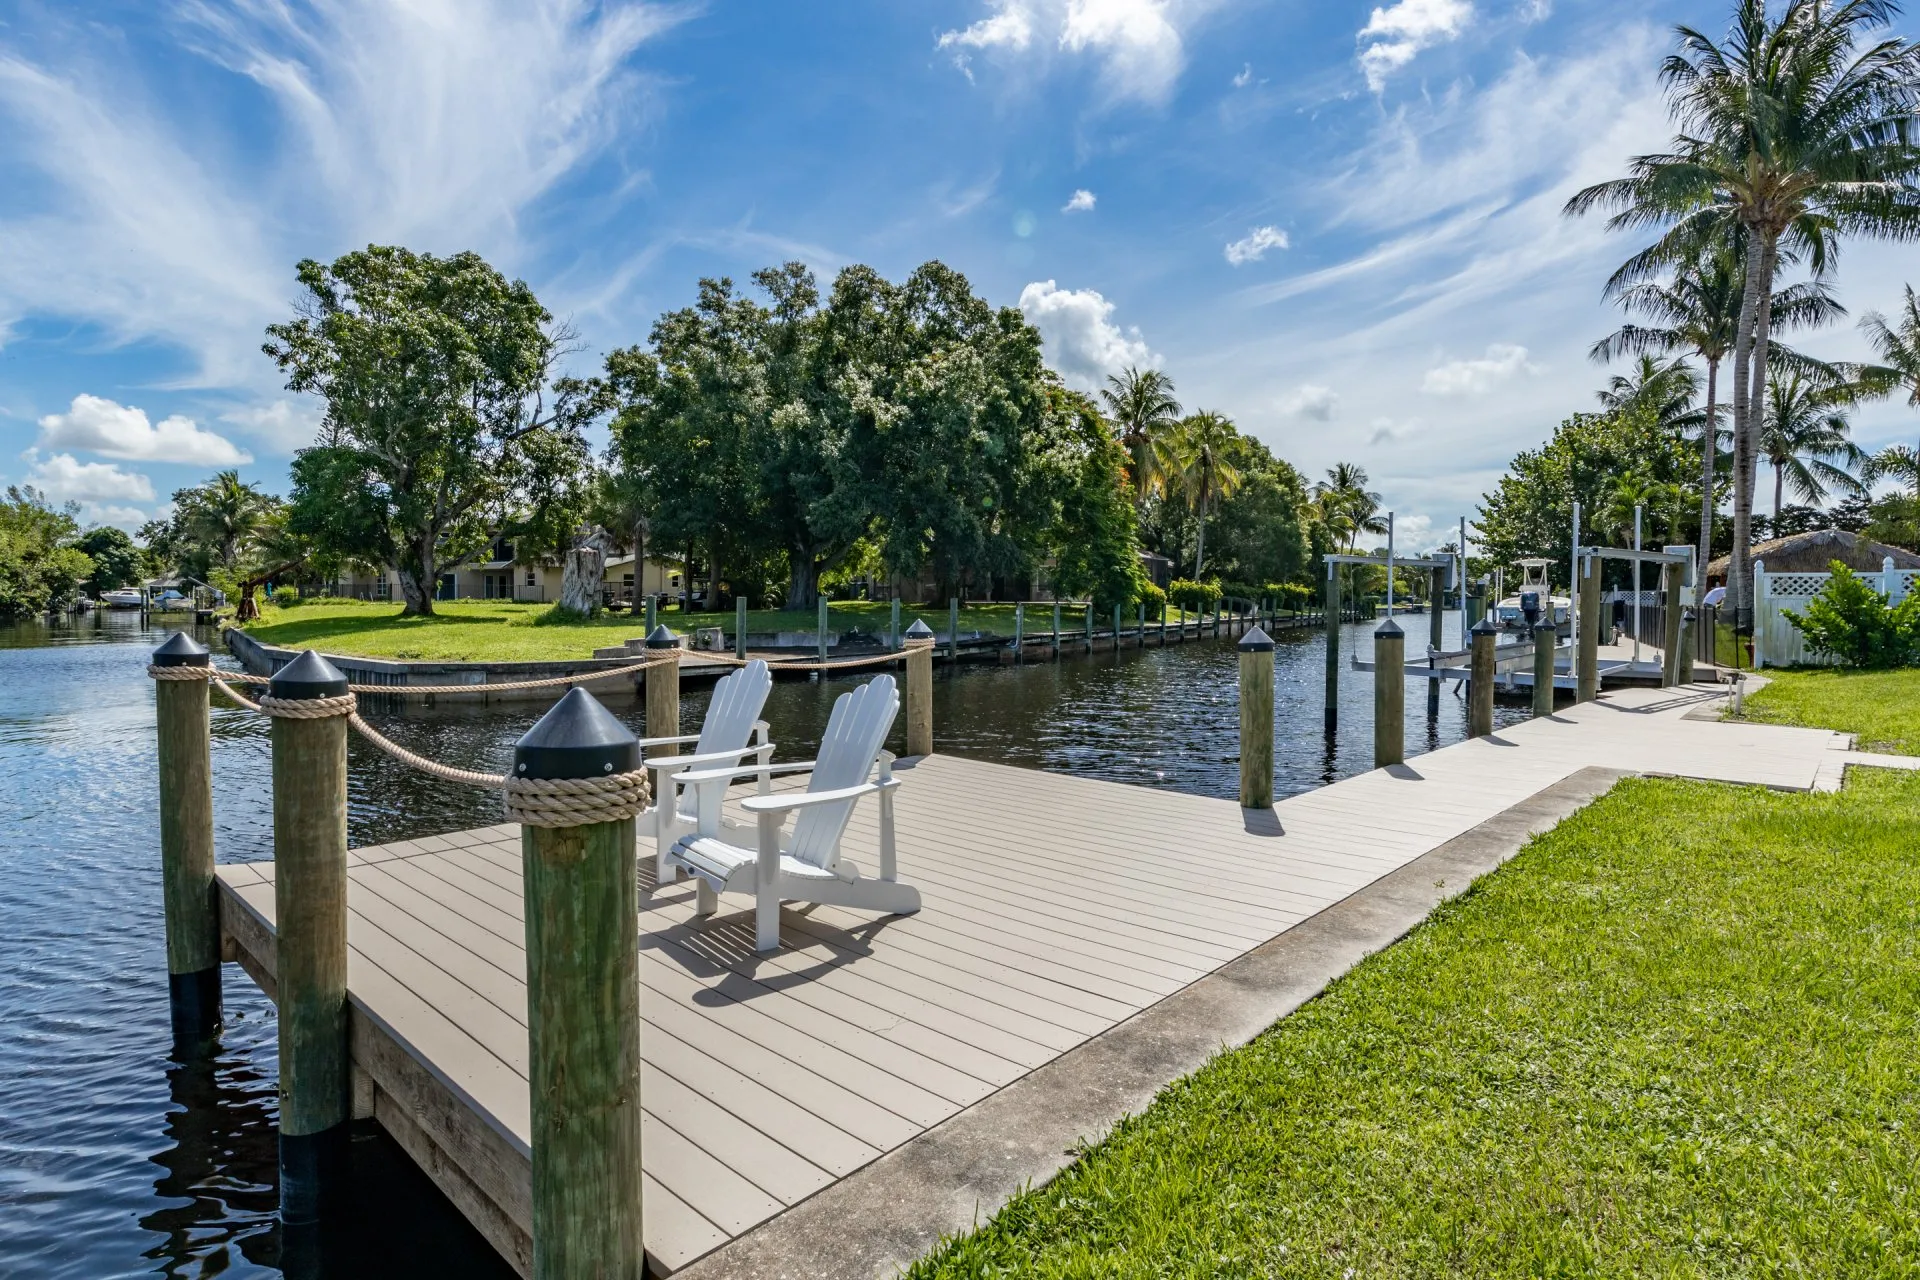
[0,614,1524,1280]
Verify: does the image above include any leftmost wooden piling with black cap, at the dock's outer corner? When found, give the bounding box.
[152,631,221,1044]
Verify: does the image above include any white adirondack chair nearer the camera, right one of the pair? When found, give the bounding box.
[666,676,920,952]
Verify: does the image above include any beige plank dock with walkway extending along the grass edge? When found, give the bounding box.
[219,687,1845,1272]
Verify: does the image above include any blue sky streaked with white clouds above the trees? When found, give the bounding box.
[0,0,1920,545]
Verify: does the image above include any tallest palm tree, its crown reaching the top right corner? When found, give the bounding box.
[1567,0,1920,626]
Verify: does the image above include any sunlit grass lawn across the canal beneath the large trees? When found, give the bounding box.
[232,601,1251,662]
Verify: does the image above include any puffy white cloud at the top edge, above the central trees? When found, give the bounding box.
[935,0,1204,104]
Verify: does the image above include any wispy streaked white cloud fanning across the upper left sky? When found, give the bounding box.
[0,0,687,390]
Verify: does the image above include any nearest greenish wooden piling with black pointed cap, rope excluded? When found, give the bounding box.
[515,689,645,1280]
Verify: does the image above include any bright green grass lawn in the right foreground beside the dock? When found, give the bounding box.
[908,770,1920,1280]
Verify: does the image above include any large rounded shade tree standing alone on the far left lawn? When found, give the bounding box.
[263,246,603,614]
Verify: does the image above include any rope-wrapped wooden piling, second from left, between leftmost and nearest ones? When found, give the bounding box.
[267,651,351,1226]
